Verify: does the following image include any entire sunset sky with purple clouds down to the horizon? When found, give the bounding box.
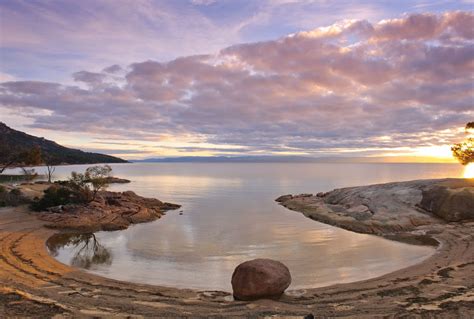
[0,0,474,161]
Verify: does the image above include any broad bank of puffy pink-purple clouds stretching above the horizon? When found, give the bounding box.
[0,11,474,158]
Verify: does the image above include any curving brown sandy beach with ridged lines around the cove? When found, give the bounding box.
[0,181,474,318]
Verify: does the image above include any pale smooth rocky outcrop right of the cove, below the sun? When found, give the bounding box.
[277,179,474,236]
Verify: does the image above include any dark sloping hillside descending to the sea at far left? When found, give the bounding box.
[0,122,127,164]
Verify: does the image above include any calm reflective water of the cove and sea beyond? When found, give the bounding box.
[39,163,463,291]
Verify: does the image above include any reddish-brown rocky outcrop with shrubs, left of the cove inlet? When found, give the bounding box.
[39,191,180,232]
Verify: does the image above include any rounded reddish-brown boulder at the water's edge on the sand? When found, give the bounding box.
[232,259,291,300]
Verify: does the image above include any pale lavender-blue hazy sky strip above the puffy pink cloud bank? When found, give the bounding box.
[0,0,473,84]
